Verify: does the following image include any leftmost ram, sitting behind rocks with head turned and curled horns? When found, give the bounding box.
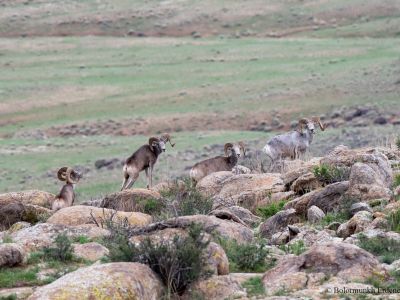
[51,167,82,210]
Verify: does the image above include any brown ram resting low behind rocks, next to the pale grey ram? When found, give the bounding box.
[190,142,246,182]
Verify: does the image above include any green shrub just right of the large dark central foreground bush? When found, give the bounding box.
[218,237,275,273]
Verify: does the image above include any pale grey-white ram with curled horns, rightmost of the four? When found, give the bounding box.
[263,117,325,165]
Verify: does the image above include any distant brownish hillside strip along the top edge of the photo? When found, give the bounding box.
[0,0,400,37]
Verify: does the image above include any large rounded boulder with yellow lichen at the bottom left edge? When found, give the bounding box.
[28,262,164,300]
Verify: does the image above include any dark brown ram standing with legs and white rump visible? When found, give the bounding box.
[121,133,175,191]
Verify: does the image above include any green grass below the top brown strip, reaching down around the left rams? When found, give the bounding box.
[0,35,400,203]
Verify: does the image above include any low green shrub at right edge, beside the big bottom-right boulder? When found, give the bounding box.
[358,234,400,264]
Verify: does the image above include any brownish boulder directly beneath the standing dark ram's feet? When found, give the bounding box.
[100,188,161,212]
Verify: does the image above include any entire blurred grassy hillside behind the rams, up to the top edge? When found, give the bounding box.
[0,0,400,200]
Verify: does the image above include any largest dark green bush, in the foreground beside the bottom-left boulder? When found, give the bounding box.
[103,218,210,298]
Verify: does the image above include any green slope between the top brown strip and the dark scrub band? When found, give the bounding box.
[0,37,400,136]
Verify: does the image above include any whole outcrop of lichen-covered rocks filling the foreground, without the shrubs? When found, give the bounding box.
[0,146,400,299]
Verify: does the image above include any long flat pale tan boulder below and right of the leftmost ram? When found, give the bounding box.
[47,205,152,226]
